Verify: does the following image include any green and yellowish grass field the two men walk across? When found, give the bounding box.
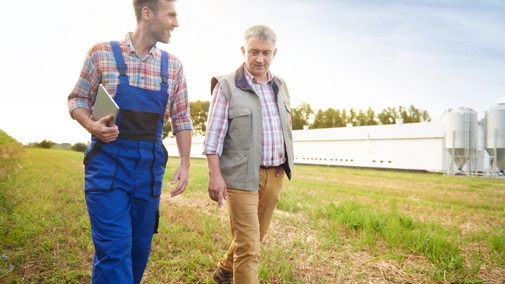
[0,149,505,283]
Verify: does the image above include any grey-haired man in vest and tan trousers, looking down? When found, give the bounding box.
[204,25,294,284]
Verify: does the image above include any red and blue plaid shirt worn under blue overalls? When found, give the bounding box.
[68,33,193,134]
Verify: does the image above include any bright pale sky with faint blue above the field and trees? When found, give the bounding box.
[0,0,505,144]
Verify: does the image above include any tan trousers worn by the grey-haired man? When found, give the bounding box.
[219,168,285,284]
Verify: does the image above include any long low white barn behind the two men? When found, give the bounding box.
[164,122,462,172]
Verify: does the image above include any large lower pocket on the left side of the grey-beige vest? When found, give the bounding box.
[219,149,249,183]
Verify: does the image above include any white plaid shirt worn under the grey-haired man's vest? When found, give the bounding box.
[203,66,286,166]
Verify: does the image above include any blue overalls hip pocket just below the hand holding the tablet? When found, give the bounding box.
[84,140,121,191]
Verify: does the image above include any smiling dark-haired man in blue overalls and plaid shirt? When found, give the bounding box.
[68,0,192,283]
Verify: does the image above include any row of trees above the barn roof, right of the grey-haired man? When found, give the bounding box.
[291,103,431,130]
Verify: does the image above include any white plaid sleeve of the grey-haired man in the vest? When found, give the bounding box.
[203,83,229,156]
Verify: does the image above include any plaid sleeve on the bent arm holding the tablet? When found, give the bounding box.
[67,48,101,119]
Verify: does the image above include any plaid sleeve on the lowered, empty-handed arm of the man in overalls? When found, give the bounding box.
[165,65,193,135]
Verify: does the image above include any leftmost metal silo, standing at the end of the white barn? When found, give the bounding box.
[445,107,477,175]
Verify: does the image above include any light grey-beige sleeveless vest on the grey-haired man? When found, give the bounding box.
[211,66,294,191]
